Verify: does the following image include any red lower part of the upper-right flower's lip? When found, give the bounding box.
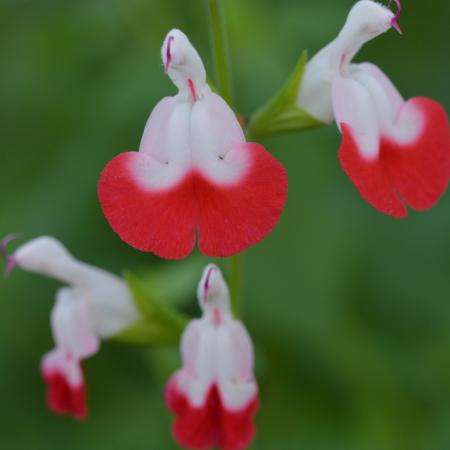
[339,97,450,218]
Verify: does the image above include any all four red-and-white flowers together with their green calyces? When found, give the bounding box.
[0,0,450,450]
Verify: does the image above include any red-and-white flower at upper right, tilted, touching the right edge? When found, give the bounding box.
[298,0,450,217]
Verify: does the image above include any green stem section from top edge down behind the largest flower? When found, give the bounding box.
[208,0,233,107]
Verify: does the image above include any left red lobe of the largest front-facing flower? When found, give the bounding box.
[98,152,196,259]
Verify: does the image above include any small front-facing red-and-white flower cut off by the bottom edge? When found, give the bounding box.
[166,265,259,450]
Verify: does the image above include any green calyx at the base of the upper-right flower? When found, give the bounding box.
[247,51,323,139]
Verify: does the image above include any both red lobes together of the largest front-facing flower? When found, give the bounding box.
[98,143,288,259]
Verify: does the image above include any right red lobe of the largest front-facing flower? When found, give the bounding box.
[195,142,288,257]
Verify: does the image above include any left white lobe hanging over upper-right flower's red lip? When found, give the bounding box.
[332,75,380,160]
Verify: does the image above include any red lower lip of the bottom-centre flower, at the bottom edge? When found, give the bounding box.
[166,378,259,450]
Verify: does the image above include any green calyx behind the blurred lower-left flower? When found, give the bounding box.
[113,273,188,345]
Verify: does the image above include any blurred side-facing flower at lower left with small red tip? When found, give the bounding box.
[2,237,139,420]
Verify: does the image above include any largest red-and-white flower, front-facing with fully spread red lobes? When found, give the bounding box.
[98,30,287,259]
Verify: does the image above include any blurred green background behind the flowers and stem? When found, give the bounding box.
[0,0,450,450]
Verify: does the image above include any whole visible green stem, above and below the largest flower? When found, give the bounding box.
[208,0,242,316]
